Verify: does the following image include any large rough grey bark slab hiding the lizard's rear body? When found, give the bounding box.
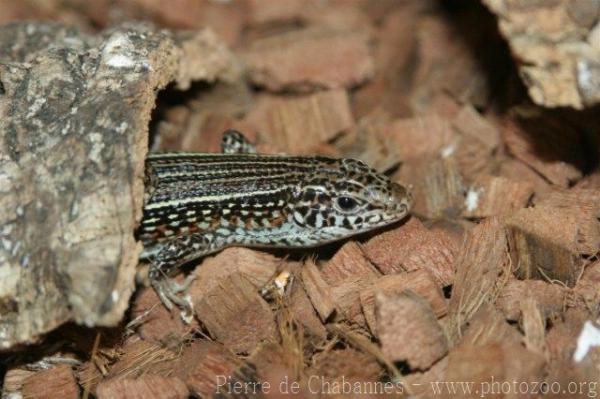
[0,22,240,349]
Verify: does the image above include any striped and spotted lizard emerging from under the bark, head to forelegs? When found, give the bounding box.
[138,131,413,318]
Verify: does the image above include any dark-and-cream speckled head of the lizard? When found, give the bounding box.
[291,158,413,241]
